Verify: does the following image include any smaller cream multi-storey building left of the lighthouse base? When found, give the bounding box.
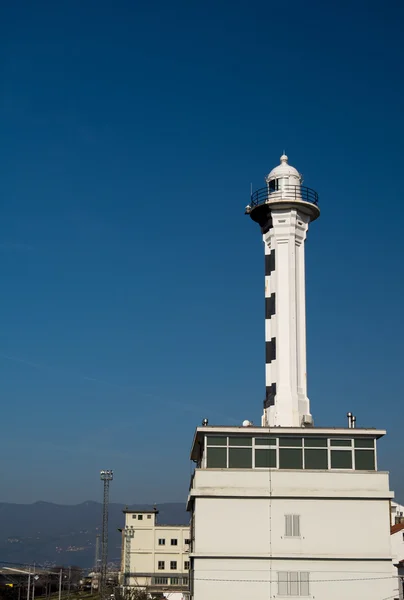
[121,510,190,598]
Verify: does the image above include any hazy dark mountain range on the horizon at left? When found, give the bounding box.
[0,501,189,568]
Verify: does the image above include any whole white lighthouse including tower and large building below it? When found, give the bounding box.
[188,155,397,600]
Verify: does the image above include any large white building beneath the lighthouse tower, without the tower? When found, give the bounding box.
[188,426,397,600]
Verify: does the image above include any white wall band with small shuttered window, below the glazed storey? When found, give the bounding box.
[194,498,390,559]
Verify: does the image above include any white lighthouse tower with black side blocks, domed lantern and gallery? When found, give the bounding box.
[246,155,320,427]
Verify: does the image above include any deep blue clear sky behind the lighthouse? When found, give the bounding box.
[0,0,404,503]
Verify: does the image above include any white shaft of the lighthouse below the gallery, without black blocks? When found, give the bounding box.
[262,208,309,427]
